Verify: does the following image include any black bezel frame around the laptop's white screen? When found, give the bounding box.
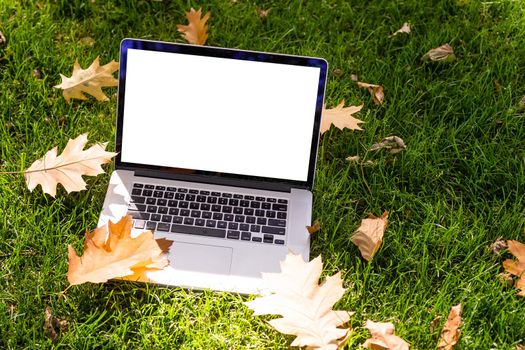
[115,39,328,190]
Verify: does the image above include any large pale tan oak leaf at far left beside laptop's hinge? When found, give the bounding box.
[24,134,116,197]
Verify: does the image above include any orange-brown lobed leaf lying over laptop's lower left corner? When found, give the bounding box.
[67,216,168,285]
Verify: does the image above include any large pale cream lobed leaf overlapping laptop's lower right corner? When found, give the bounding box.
[245,253,352,350]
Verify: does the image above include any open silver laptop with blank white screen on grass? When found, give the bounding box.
[99,39,327,294]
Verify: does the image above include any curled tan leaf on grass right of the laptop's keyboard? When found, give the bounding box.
[351,210,388,261]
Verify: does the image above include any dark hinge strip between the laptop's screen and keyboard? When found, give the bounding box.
[131,169,292,192]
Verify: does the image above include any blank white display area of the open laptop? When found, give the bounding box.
[121,49,320,181]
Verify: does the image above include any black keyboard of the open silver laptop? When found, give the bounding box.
[128,183,288,244]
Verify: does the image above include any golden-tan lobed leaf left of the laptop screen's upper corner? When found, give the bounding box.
[55,57,118,102]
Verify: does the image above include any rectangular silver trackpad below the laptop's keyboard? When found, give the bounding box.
[169,241,233,275]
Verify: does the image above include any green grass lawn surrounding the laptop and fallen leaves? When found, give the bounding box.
[0,0,525,350]
